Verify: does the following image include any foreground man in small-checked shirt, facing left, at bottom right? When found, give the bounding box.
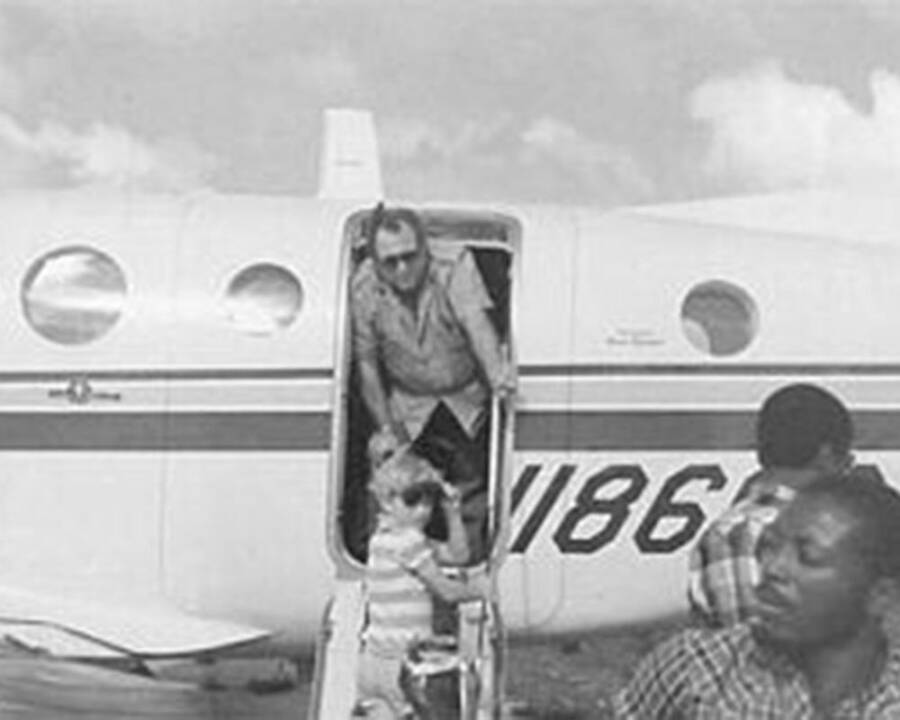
[615,475,900,720]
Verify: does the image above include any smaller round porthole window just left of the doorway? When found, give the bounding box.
[225,263,303,335]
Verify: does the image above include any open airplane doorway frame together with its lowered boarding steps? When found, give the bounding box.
[309,208,520,720]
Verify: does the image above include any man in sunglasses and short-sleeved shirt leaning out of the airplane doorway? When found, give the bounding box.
[350,206,513,556]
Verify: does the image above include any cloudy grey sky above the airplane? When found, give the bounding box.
[0,0,900,206]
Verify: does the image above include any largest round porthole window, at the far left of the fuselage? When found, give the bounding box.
[22,246,127,345]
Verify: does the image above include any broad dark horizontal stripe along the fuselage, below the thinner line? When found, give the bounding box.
[0,410,900,452]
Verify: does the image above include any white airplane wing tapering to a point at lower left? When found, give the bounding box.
[0,585,270,659]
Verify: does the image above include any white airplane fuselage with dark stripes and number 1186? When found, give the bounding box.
[0,194,900,647]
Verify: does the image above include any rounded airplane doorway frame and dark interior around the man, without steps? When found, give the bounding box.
[332,208,520,567]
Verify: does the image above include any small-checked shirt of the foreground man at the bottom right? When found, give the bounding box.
[613,624,900,720]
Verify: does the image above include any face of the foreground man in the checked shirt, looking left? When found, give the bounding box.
[756,494,873,649]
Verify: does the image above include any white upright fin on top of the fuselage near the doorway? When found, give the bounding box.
[319,110,383,200]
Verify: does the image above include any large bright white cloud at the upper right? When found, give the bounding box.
[690,64,900,190]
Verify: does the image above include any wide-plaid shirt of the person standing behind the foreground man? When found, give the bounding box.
[688,469,810,627]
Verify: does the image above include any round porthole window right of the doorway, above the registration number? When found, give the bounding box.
[681,280,758,356]
